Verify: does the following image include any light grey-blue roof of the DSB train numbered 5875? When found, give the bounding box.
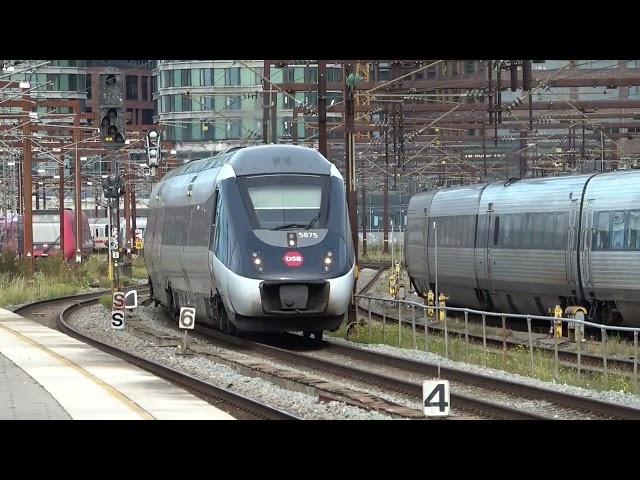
[163,145,331,180]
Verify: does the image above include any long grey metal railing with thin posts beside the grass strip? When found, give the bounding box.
[354,295,640,392]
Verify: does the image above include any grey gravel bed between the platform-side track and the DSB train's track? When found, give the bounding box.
[67,305,394,420]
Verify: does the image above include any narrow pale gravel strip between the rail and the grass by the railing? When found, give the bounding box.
[325,337,640,408]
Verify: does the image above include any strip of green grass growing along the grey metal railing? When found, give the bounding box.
[333,309,634,393]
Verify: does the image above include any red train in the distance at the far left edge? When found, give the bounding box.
[0,209,93,260]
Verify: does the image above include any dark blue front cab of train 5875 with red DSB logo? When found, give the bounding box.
[210,167,354,331]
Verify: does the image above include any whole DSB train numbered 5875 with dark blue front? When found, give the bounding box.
[145,145,355,338]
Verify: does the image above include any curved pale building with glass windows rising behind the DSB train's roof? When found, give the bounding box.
[153,60,342,158]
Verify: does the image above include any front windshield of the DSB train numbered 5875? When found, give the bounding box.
[239,175,329,230]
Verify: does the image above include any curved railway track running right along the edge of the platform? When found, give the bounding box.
[15,286,298,420]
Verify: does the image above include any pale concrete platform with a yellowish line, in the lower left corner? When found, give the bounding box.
[0,309,233,420]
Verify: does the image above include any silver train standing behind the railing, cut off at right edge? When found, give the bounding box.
[405,170,640,326]
